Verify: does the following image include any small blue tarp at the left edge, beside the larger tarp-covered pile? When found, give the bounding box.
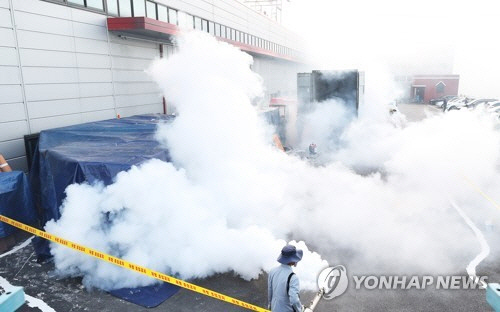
[0,171,36,237]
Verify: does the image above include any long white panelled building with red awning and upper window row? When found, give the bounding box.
[0,0,302,170]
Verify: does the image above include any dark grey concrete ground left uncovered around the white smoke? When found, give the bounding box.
[0,104,500,312]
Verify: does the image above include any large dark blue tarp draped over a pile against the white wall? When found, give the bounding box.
[30,114,173,256]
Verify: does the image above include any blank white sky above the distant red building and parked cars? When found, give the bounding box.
[282,0,500,98]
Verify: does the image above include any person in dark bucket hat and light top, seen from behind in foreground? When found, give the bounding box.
[267,245,304,312]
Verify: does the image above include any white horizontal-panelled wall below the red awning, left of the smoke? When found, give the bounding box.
[0,0,163,170]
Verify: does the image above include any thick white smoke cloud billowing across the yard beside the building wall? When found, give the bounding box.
[46,33,500,294]
